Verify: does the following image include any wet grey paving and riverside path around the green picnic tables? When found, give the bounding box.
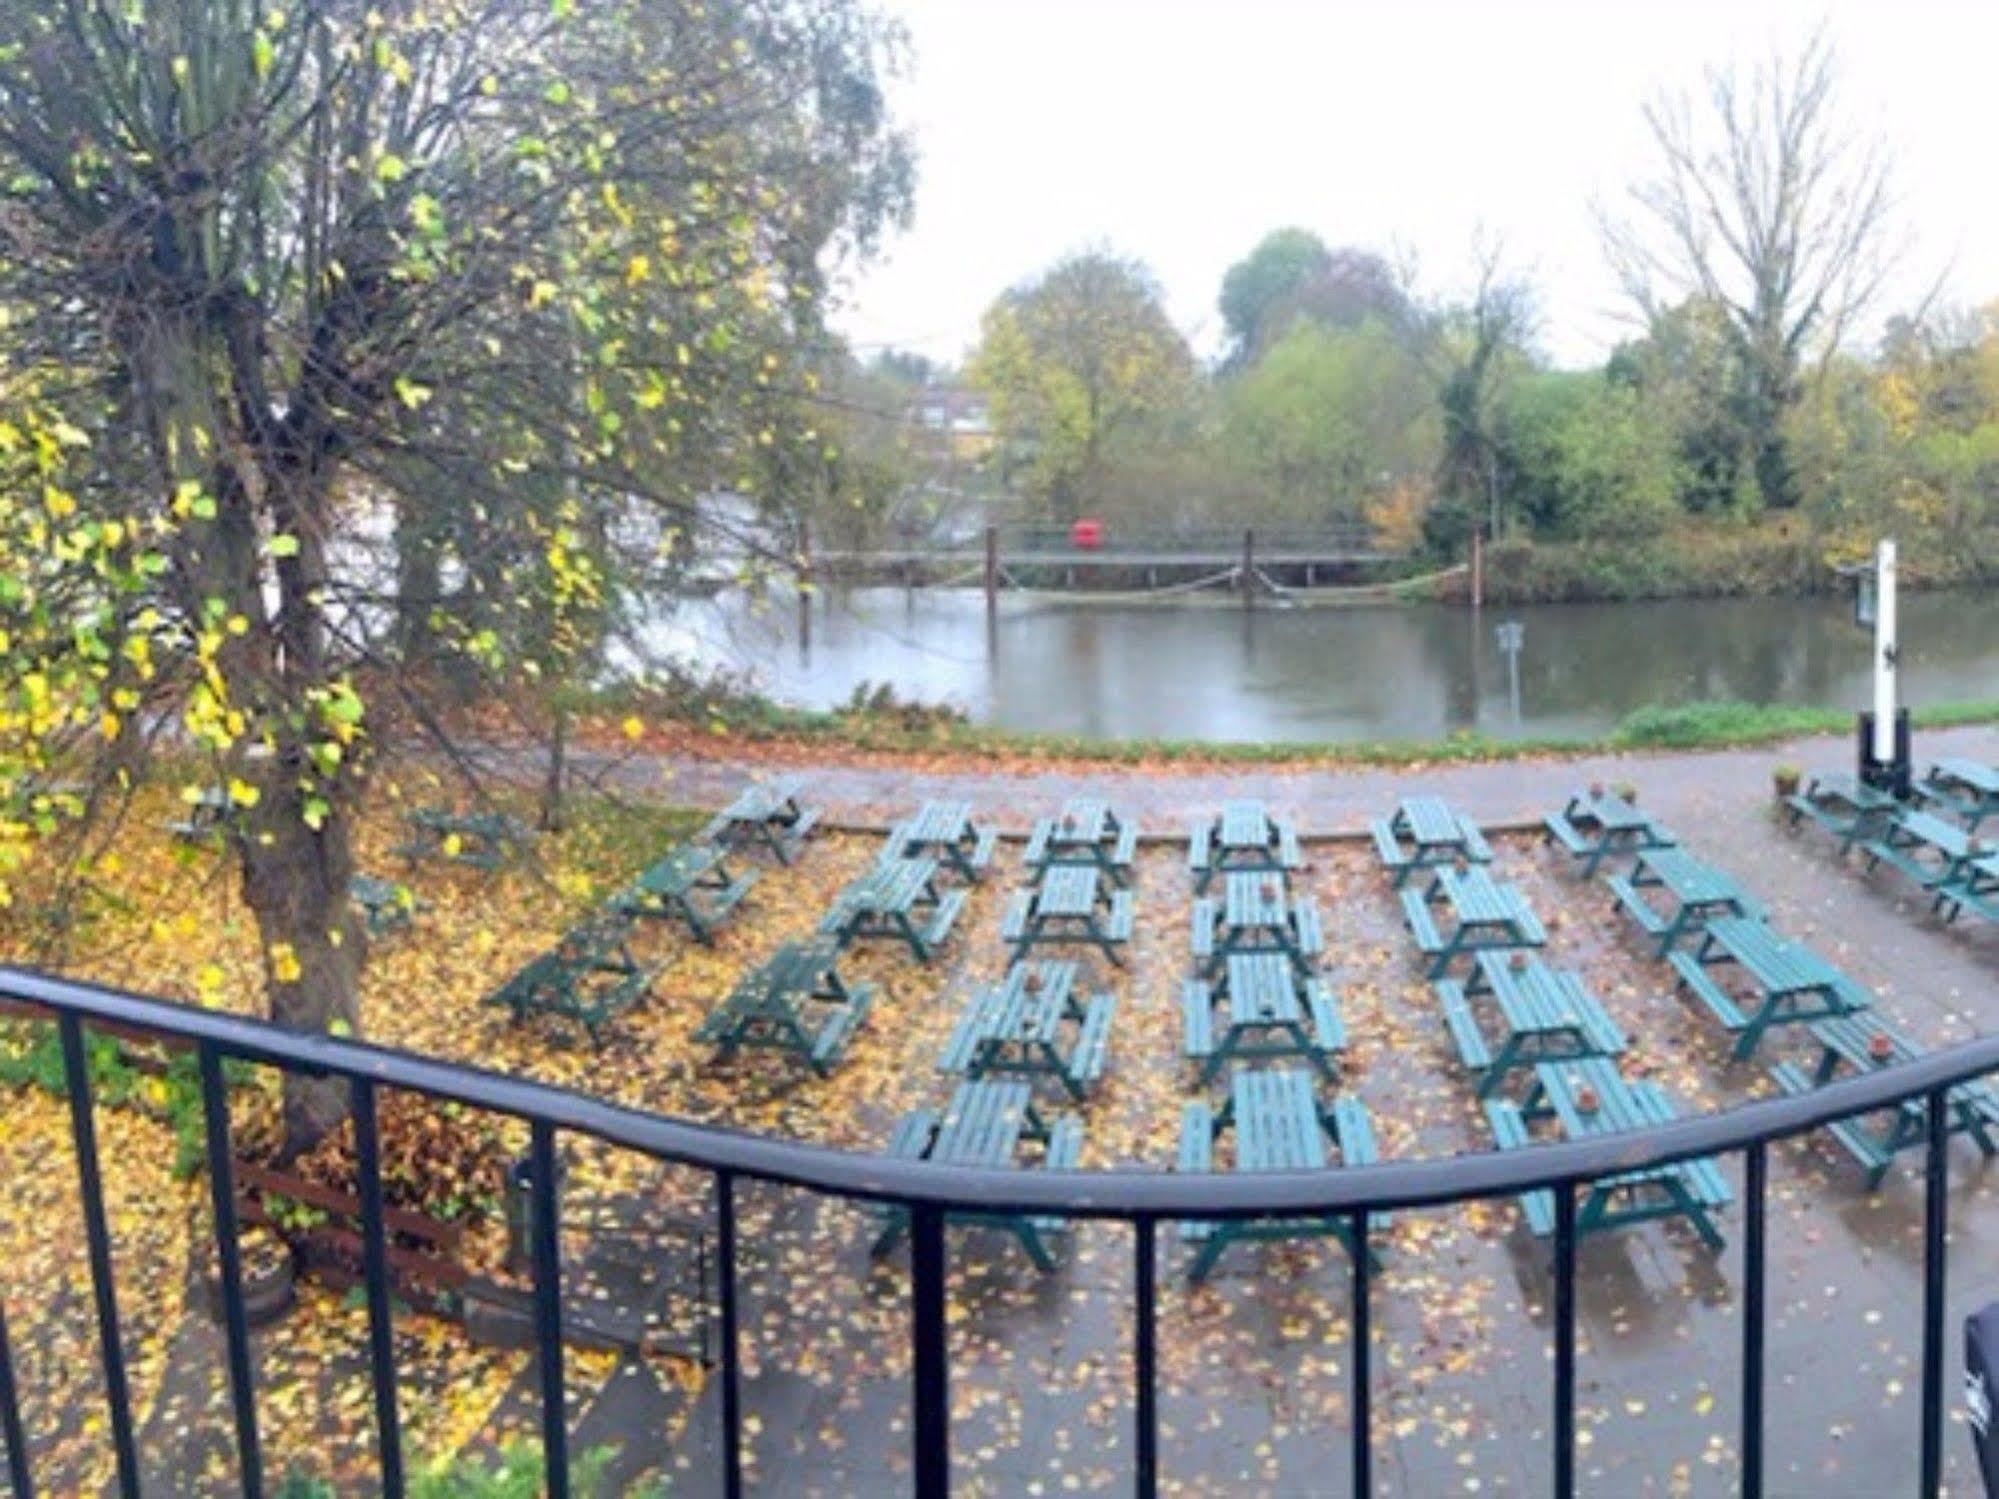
[611,730,1999,1495]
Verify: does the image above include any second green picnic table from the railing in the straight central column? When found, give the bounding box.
[1179,953,1347,1087]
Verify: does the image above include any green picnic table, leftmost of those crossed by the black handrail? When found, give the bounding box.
[874,1077,1083,1271]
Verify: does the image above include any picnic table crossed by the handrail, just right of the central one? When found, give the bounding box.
[1485,1057,1733,1251]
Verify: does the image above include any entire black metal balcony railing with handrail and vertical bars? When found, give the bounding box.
[0,967,1999,1497]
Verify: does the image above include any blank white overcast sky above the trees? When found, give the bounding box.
[838,0,1999,373]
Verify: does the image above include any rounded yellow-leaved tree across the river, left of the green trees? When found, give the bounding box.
[970,250,1193,522]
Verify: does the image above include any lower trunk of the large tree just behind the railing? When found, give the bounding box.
[238,775,368,1157]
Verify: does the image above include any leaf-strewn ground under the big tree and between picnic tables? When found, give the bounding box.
[0,767,1999,1493]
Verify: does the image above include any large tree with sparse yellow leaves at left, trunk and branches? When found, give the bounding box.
[0,0,910,1147]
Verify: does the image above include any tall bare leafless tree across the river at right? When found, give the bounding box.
[1599,34,1891,508]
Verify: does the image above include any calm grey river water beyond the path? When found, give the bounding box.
[656,588,1999,740]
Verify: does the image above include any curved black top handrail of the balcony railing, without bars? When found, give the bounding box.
[0,965,1999,1221]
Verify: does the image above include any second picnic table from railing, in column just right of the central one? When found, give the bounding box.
[1435,951,1625,1097]
